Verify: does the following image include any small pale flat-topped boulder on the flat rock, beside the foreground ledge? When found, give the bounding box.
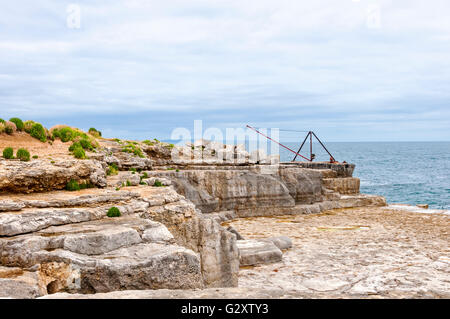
[237,240,283,266]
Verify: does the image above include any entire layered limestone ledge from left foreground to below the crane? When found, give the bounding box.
[0,140,386,298]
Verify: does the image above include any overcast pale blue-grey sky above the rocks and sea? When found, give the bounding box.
[0,0,450,141]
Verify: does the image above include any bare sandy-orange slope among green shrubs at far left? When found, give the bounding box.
[0,132,73,159]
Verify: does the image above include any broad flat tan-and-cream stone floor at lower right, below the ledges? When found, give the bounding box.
[230,208,450,298]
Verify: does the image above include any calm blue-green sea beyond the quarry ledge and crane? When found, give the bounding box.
[280,142,450,209]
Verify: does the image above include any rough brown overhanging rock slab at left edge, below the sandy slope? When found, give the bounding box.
[0,160,106,193]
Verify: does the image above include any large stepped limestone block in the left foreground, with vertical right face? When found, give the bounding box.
[0,187,239,298]
